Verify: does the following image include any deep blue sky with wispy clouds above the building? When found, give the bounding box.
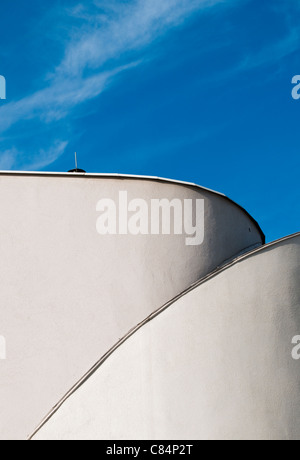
[0,0,300,241]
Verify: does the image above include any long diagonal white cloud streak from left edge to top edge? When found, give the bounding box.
[0,0,222,133]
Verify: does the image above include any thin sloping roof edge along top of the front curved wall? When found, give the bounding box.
[28,232,300,441]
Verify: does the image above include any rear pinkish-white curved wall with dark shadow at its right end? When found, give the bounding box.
[0,173,262,439]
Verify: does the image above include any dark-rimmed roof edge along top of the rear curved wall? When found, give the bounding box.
[0,171,266,245]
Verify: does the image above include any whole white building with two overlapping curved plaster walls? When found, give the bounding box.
[0,172,300,439]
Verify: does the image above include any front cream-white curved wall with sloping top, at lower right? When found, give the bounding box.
[34,234,300,440]
